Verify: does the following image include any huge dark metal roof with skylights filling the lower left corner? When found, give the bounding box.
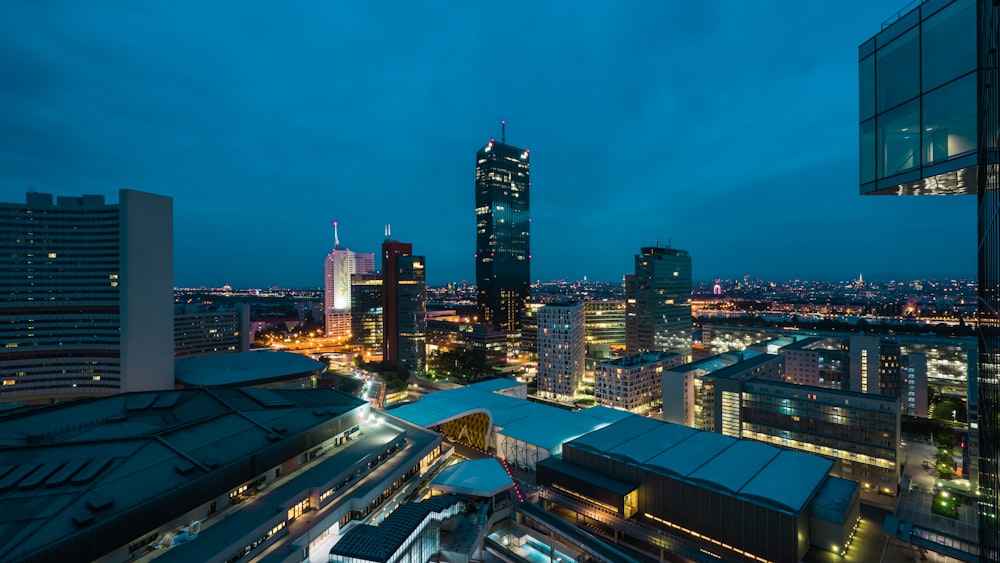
[0,389,367,560]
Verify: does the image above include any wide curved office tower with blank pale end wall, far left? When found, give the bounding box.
[0,190,174,400]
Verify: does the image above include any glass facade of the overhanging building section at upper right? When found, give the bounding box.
[858,0,977,194]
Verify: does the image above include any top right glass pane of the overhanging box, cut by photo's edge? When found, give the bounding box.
[921,0,976,92]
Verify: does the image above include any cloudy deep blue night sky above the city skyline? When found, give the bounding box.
[0,0,976,287]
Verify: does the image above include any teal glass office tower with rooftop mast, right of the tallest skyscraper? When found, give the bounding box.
[625,246,691,358]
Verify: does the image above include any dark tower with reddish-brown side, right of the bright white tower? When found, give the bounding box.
[382,239,427,371]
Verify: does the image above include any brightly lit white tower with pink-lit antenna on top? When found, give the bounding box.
[323,221,375,338]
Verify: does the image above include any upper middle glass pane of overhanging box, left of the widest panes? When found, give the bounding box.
[875,27,920,113]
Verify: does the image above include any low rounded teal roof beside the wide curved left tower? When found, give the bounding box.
[174,350,326,387]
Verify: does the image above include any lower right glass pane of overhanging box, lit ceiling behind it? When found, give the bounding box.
[922,73,976,164]
